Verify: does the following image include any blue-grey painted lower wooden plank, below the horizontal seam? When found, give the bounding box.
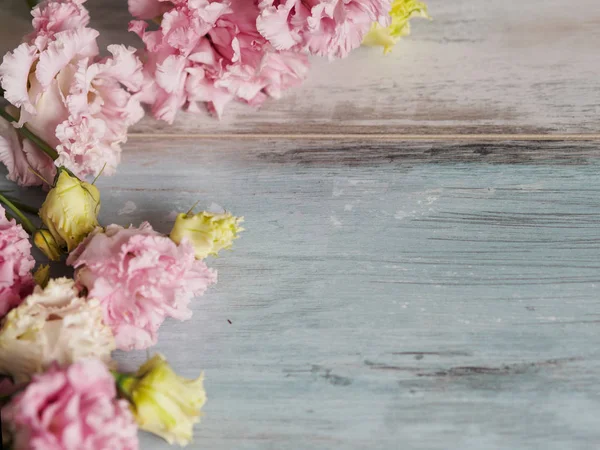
[0,139,600,450]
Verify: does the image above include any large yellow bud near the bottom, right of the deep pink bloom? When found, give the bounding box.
[116,354,206,446]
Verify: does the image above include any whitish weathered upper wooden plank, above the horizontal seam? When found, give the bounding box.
[0,0,600,135]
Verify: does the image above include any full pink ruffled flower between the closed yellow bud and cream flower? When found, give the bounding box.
[67,222,217,350]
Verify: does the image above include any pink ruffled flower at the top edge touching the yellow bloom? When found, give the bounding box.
[257,0,391,59]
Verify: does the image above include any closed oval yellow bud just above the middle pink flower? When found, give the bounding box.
[40,170,100,252]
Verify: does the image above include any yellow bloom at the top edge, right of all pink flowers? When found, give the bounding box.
[363,0,429,53]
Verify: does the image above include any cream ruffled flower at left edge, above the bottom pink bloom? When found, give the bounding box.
[0,278,115,383]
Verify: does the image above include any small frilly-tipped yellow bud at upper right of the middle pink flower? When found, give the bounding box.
[170,211,244,259]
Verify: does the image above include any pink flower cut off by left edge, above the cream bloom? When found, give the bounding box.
[0,206,35,317]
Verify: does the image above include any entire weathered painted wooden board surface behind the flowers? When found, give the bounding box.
[0,0,600,450]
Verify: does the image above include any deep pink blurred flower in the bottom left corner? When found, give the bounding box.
[2,359,138,450]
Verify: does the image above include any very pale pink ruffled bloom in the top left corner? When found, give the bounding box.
[0,0,144,186]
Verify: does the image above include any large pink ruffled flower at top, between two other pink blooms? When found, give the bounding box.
[129,0,308,122]
